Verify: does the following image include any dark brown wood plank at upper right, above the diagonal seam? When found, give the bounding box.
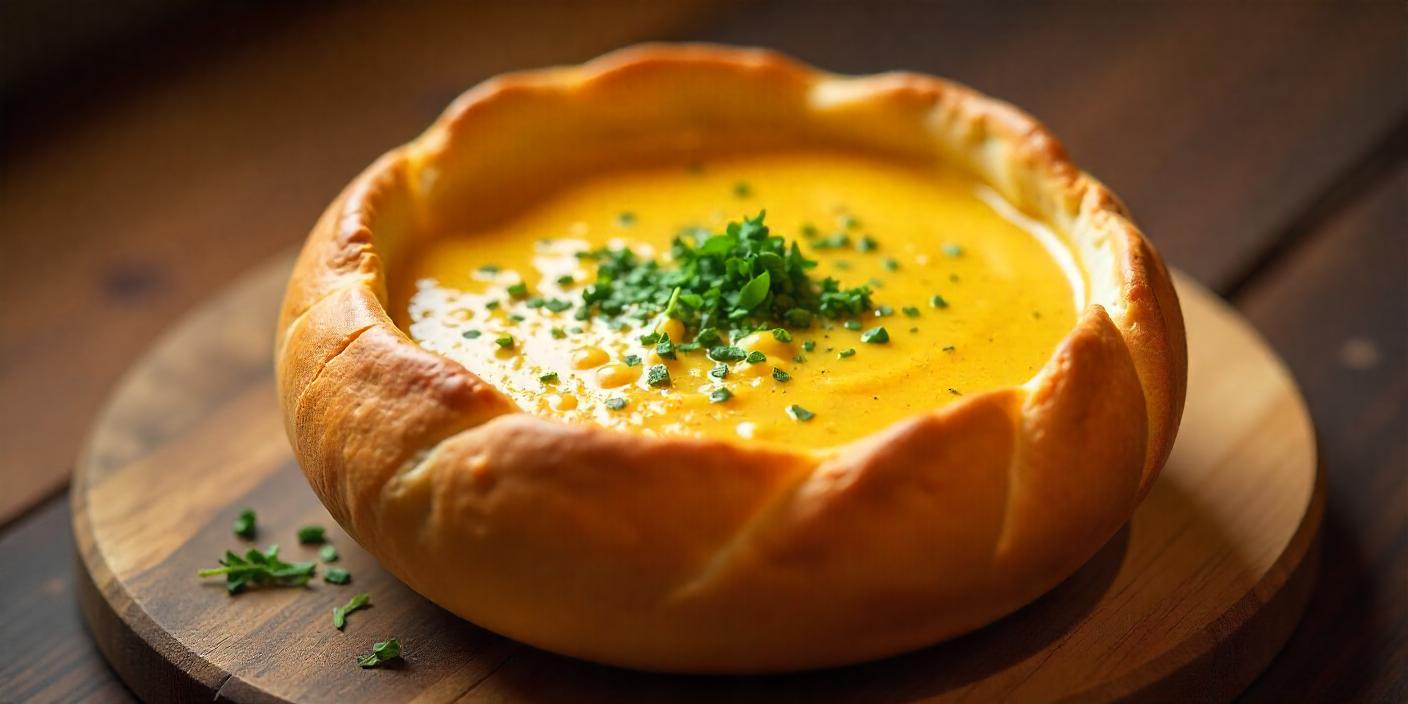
[708,0,1408,293]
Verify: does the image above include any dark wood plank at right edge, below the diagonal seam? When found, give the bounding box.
[1239,159,1408,701]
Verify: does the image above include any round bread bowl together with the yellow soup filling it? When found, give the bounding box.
[275,45,1187,673]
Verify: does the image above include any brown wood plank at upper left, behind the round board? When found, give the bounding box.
[0,0,717,524]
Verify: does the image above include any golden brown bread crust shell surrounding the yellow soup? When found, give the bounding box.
[276,45,1187,672]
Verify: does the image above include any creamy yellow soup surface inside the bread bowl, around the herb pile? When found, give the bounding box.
[394,152,1086,449]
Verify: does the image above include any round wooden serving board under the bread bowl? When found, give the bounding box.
[72,259,1325,701]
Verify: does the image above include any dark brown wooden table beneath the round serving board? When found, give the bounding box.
[0,0,1408,701]
